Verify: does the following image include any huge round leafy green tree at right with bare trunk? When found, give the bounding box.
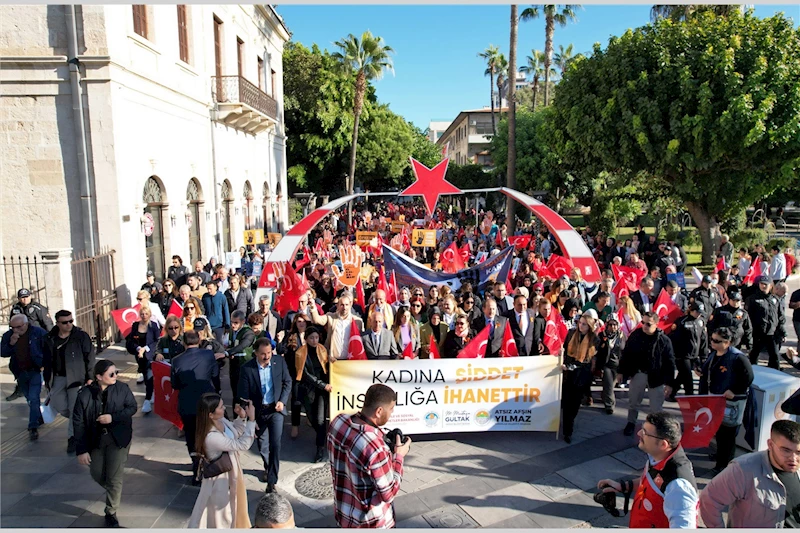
[552,11,800,264]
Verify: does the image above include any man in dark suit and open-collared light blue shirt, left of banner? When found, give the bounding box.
[239,338,292,492]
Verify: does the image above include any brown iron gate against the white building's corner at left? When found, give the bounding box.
[72,248,118,353]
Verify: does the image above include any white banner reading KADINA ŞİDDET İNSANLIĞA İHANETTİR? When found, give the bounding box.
[330,356,561,435]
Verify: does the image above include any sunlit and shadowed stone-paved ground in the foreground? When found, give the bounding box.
[0,279,800,528]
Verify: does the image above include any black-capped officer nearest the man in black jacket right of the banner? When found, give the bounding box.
[667,302,708,402]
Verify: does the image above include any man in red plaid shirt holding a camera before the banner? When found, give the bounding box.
[328,383,411,528]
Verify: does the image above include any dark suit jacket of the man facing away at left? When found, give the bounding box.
[171,348,219,415]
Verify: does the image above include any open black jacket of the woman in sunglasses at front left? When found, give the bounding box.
[72,381,137,455]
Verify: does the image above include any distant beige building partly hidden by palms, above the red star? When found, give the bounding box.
[436,107,508,170]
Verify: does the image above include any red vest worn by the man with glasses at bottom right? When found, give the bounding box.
[628,446,697,529]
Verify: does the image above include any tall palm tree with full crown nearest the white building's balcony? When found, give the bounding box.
[332,31,394,223]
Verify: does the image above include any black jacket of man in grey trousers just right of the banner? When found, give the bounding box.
[619,329,675,387]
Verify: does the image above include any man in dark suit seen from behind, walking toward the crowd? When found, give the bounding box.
[171,328,219,485]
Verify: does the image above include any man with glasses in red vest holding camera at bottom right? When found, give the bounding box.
[595,412,698,529]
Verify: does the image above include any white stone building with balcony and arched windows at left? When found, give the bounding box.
[0,5,290,305]
